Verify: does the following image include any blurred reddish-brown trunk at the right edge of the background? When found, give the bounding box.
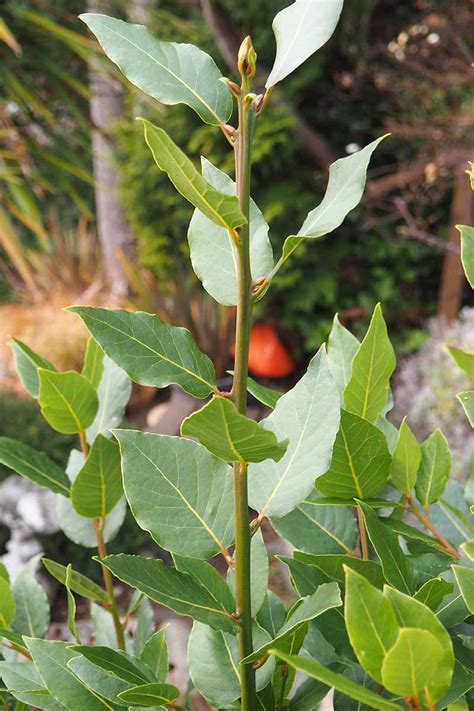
[438,170,472,323]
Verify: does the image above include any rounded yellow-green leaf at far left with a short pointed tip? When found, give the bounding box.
[38,368,99,434]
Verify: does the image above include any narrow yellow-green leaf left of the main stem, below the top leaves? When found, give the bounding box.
[141,119,247,230]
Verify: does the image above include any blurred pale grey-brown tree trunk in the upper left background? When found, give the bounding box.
[87,0,133,296]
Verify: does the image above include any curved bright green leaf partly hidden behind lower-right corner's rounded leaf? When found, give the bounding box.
[384,586,454,701]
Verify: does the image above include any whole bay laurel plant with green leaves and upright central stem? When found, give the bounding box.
[0,0,474,711]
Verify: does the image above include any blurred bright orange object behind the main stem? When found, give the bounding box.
[249,323,295,378]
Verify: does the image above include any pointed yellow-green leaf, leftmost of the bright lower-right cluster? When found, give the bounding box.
[344,566,399,683]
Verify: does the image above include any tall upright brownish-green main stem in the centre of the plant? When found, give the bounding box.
[232,69,256,711]
